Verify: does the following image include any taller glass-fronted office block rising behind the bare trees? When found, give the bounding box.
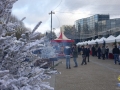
[75,14,109,41]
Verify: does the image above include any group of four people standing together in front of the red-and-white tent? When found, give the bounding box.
[64,44,90,69]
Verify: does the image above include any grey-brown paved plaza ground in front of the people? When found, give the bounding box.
[54,56,120,90]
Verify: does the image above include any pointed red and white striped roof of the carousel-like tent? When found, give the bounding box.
[52,30,74,42]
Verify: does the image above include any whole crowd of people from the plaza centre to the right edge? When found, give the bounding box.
[63,44,120,69]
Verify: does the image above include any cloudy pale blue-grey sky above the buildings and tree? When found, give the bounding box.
[12,0,120,33]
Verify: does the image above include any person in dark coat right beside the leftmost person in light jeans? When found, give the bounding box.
[72,44,78,67]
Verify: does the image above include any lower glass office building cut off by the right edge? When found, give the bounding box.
[98,18,120,37]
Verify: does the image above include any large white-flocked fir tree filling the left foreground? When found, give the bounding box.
[0,0,58,90]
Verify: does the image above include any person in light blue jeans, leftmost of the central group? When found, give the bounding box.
[64,46,72,69]
